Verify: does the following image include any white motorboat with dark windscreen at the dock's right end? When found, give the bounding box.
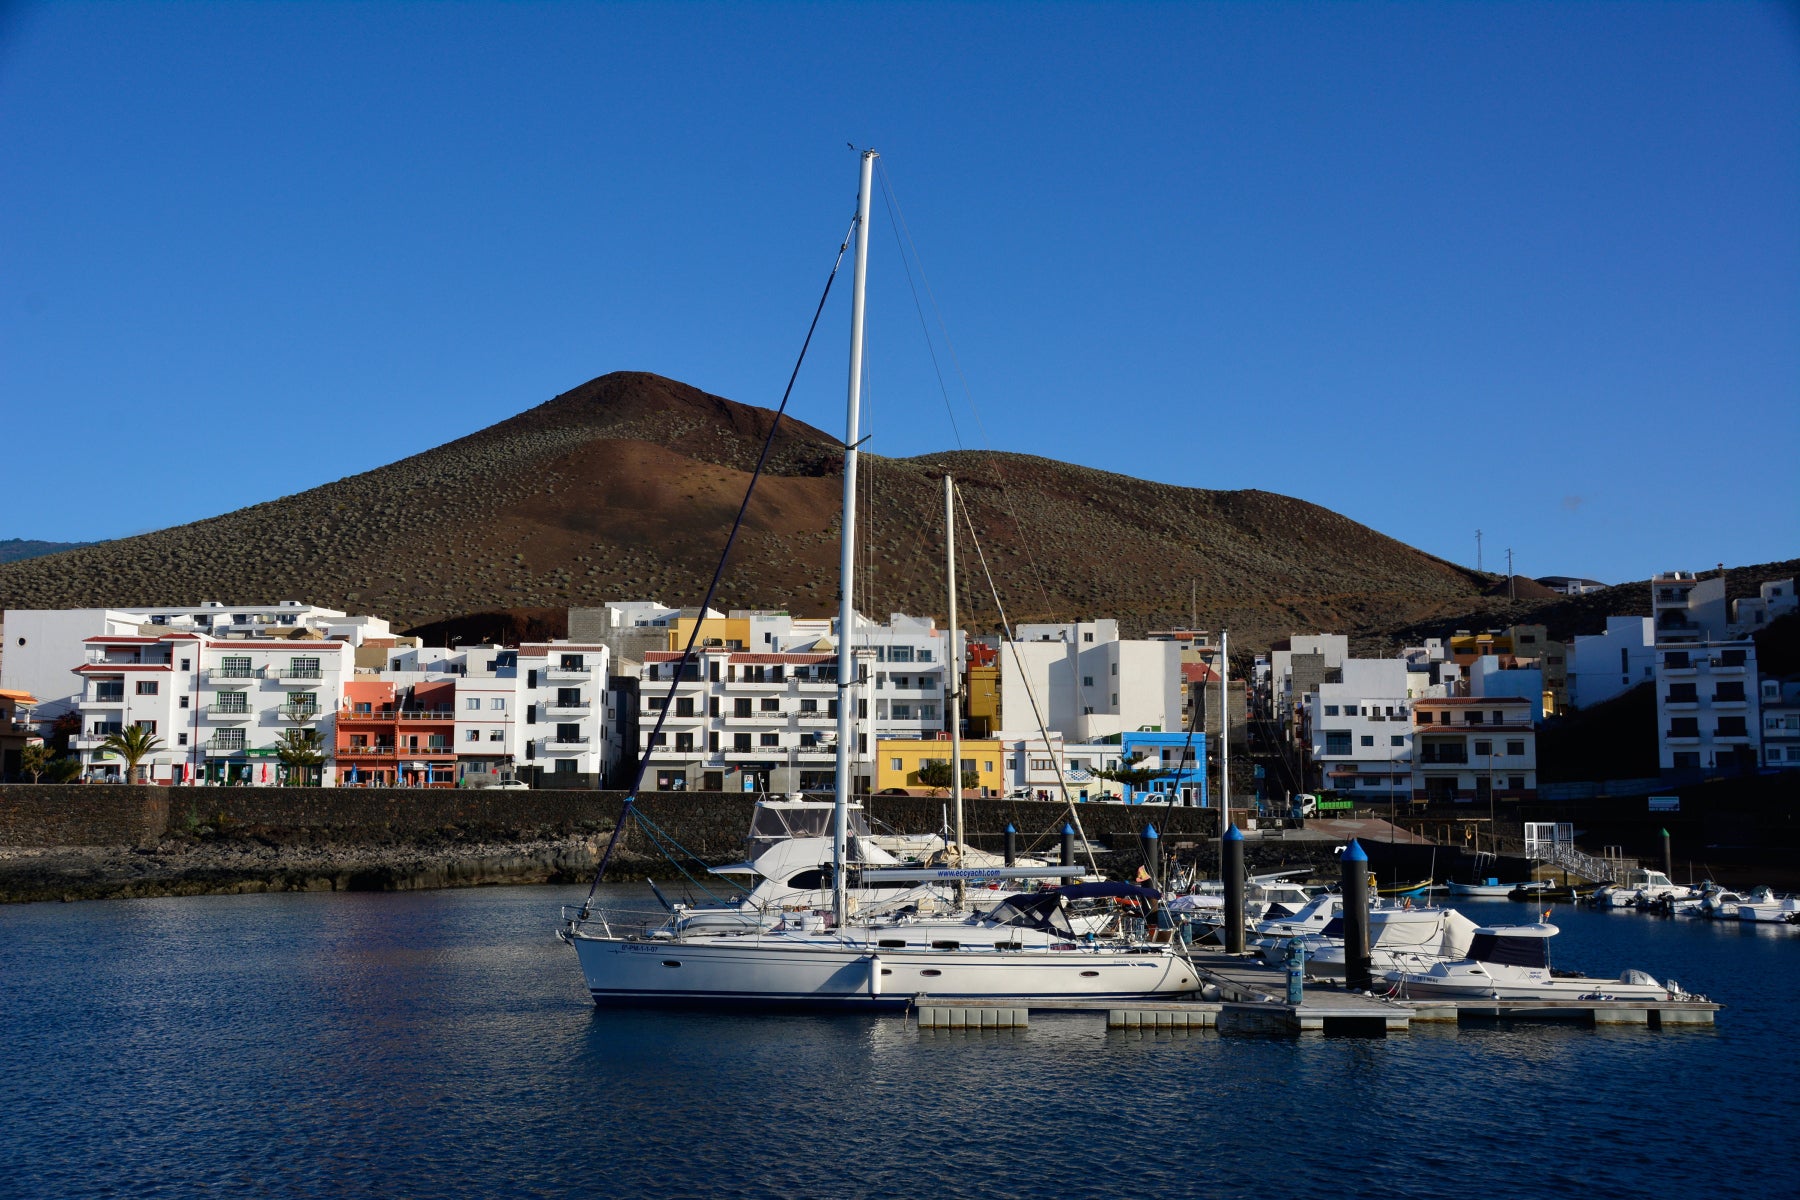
[1382,921,1694,1000]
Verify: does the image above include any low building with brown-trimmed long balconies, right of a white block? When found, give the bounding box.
[1413,696,1537,804]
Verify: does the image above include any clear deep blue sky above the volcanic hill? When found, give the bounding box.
[0,2,1800,581]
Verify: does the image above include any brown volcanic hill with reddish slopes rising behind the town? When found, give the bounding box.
[0,372,1492,646]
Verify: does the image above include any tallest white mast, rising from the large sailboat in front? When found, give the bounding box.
[832,149,875,928]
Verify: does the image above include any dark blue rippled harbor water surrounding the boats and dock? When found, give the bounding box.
[0,885,1800,1198]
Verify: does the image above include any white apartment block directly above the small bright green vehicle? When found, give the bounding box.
[1301,658,1413,802]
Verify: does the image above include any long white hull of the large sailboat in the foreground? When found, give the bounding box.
[569,932,1199,1011]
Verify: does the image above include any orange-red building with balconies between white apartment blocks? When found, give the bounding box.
[335,680,455,788]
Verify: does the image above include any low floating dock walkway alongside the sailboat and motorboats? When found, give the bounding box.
[913,952,1724,1038]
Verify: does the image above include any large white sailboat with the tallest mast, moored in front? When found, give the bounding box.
[558,151,1199,1009]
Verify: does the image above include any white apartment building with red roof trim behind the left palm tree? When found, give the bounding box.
[74,630,355,784]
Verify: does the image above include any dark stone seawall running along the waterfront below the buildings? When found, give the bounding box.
[0,784,1252,901]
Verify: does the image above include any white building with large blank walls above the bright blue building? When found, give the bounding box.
[997,619,1183,743]
